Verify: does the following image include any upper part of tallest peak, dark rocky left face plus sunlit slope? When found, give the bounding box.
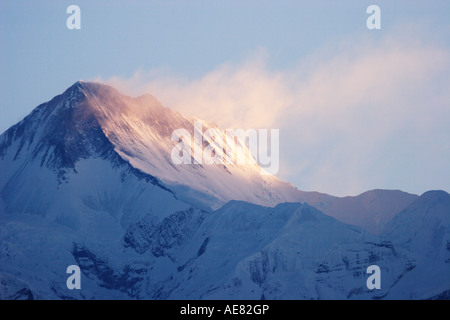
[0,81,316,208]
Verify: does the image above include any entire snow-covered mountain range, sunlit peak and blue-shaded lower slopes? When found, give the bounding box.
[0,81,450,299]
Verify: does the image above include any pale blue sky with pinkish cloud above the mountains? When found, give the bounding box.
[0,0,450,195]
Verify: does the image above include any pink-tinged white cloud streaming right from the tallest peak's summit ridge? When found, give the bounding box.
[98,33,450,195]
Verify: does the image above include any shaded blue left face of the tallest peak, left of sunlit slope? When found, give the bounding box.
[0,85,205,298]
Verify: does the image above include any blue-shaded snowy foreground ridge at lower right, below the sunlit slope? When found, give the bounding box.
[117,201,450,299]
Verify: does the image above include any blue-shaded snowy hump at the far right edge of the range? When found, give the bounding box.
[382,191,450,299]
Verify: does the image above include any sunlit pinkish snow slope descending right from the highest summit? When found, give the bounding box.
[59,82,312,208]
